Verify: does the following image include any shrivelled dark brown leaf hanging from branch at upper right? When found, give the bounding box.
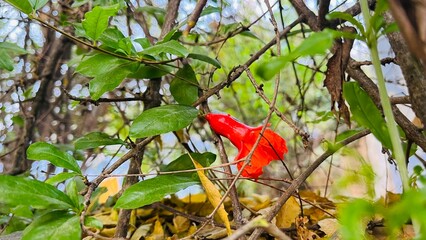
[324,27,356,127]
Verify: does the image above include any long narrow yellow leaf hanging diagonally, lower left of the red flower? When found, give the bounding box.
[189,154,232,236]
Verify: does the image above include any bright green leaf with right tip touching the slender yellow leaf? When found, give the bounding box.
[114,175,199,209]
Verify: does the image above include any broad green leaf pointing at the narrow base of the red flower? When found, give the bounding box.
[130,105,198,138]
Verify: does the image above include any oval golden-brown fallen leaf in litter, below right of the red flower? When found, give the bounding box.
[275,196,300,228]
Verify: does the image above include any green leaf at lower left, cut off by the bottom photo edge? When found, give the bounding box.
[22,211,81,240]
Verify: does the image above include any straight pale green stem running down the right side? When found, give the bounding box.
[360,0,410,191]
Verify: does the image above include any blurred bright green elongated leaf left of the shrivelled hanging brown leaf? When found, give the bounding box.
[256,29,342,80]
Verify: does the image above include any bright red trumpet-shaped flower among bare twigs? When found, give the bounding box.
[205,113,288,179]
